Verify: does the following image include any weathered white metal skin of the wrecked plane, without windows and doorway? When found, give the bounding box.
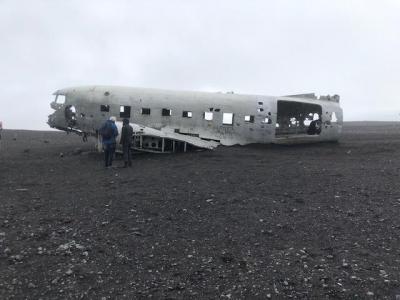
[48,86,343,149]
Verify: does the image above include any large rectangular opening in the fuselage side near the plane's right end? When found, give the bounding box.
[275,100,322,137]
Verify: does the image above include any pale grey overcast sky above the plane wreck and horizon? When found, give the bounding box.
[0,0,400,129]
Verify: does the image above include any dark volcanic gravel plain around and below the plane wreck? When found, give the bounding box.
[0,122,400,300]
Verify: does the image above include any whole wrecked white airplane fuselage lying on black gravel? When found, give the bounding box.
[48,86,343,153]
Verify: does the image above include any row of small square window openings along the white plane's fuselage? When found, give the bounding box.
[100,105,272,125]
